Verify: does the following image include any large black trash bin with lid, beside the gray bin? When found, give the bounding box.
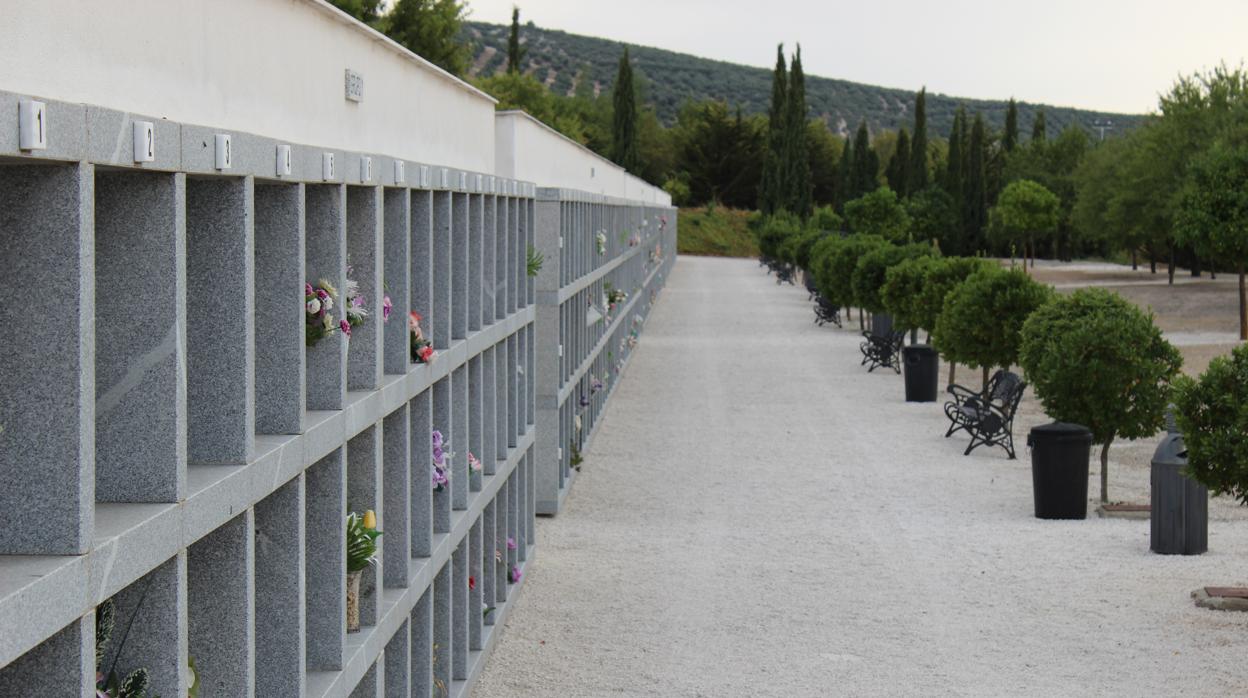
[1027,422,1092,518]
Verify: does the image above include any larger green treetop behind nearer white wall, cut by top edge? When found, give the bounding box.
[378,0,469,75]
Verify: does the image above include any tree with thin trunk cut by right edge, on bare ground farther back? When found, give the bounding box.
[1176,142,1248,340]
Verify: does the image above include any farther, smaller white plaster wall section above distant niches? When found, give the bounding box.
[494,111,671,206]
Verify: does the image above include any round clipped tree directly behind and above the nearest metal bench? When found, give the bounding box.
[932,267,1053,397]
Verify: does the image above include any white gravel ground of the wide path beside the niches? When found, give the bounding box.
[478,257,1248,697]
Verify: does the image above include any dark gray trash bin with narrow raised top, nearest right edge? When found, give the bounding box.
[1148,431,1209,554]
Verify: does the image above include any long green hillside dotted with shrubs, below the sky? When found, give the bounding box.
[464,22,1142,137]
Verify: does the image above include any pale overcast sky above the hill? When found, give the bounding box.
[468,0,1248,112]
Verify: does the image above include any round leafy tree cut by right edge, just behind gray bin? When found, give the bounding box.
[1174,345,1248,504]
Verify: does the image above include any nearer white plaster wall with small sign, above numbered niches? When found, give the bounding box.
[0,0,494,172]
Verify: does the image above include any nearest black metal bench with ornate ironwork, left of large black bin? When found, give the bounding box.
[945,370,1027,460]
